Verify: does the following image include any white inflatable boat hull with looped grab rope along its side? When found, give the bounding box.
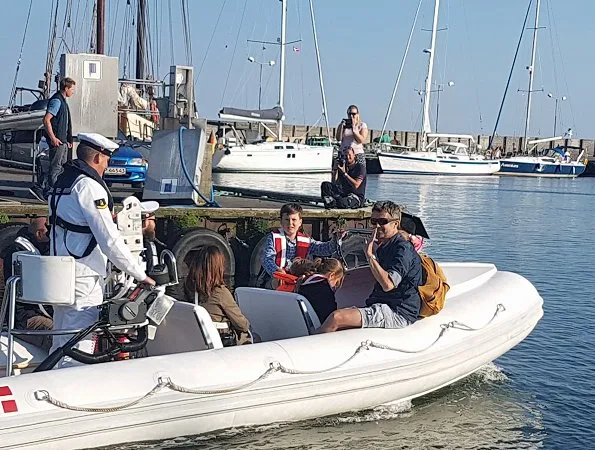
[0,264,543,450]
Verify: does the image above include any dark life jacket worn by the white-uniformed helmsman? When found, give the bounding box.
[49,159,114,259]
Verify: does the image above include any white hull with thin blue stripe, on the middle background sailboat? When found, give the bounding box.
[378,152,500,175]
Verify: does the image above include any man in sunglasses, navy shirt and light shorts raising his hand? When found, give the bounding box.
[319,201,422,333]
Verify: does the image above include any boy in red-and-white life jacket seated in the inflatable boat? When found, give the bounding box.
[256,203,337,289]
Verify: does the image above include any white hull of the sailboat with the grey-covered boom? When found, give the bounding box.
[213,142,333,173]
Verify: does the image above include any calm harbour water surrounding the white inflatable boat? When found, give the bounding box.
[140,175,595,450]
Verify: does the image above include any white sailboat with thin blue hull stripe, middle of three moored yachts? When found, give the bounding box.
[378,0,500,175]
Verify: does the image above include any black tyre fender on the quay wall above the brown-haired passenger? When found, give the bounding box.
[171,228,236,300]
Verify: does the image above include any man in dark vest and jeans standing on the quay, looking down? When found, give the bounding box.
[43,77,76,195]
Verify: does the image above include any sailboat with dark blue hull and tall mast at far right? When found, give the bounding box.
[497,0,586,178]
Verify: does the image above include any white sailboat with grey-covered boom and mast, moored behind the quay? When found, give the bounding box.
[213,0,333,173]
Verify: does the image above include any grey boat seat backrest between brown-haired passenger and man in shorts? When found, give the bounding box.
[235,287,320,342]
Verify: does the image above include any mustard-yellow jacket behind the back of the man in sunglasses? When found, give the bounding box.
[417,254,450,317]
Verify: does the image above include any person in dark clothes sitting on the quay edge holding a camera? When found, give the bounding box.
[320,147,366,209]
